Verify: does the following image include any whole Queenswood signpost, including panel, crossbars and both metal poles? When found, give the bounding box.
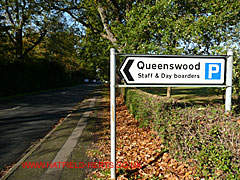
[110,48,233,179]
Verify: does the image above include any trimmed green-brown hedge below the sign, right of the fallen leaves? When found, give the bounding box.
[126,89,240,179]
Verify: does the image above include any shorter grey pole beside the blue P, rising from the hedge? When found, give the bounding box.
[225,49,233,112]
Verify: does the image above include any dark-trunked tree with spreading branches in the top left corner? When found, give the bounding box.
[0,0,56,59]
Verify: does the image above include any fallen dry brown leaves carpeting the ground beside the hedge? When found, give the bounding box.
[89,98,199,180]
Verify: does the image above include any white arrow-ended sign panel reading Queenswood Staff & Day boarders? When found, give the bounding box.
[119,55,226,85]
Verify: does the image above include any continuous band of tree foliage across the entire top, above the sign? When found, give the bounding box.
[0,0,240,93]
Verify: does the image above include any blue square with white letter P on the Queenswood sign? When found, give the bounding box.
[205,63,221,80]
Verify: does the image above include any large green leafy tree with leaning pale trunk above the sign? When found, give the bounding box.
[51,0,240,91]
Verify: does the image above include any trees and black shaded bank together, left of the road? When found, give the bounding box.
[0,1,95,96]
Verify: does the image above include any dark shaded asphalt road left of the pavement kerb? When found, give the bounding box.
[0,85,96,168]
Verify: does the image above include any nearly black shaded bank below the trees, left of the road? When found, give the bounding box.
[0,59,86,97]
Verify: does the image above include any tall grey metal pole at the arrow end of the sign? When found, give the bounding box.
[110,48,116,180]
